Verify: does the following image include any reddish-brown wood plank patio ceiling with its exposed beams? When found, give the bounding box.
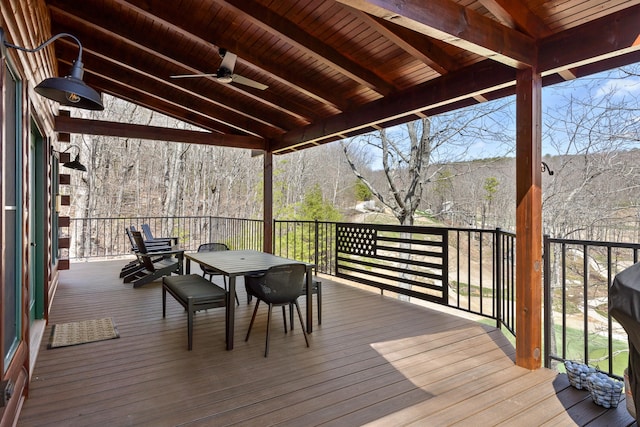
[45,0,640,153]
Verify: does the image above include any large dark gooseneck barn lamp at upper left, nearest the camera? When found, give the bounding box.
[0,28,104,110]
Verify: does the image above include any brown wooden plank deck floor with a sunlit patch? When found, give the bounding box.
[18,261,633,427]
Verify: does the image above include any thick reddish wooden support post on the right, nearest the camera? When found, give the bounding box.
[515,68,542,369]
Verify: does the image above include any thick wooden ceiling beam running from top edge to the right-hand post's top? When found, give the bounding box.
[337,0,535,67]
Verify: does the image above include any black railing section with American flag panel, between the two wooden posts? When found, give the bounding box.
[274,221,515,335]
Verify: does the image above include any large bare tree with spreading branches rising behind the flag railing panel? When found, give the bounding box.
[342,100,511,225]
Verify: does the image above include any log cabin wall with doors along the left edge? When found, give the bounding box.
[0,0,58,427]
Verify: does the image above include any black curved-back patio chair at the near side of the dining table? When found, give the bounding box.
[245,263,309,357]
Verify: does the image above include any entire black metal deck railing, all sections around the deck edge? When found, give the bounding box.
[65,217,640,376]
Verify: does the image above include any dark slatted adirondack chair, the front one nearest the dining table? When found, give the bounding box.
[124,231,184,288]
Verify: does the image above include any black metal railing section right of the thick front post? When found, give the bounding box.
[544,236,640,377]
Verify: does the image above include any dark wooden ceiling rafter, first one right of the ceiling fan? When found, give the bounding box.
[215,0,396,95]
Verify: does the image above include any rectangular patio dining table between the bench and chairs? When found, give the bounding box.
[184,251,315,350]
